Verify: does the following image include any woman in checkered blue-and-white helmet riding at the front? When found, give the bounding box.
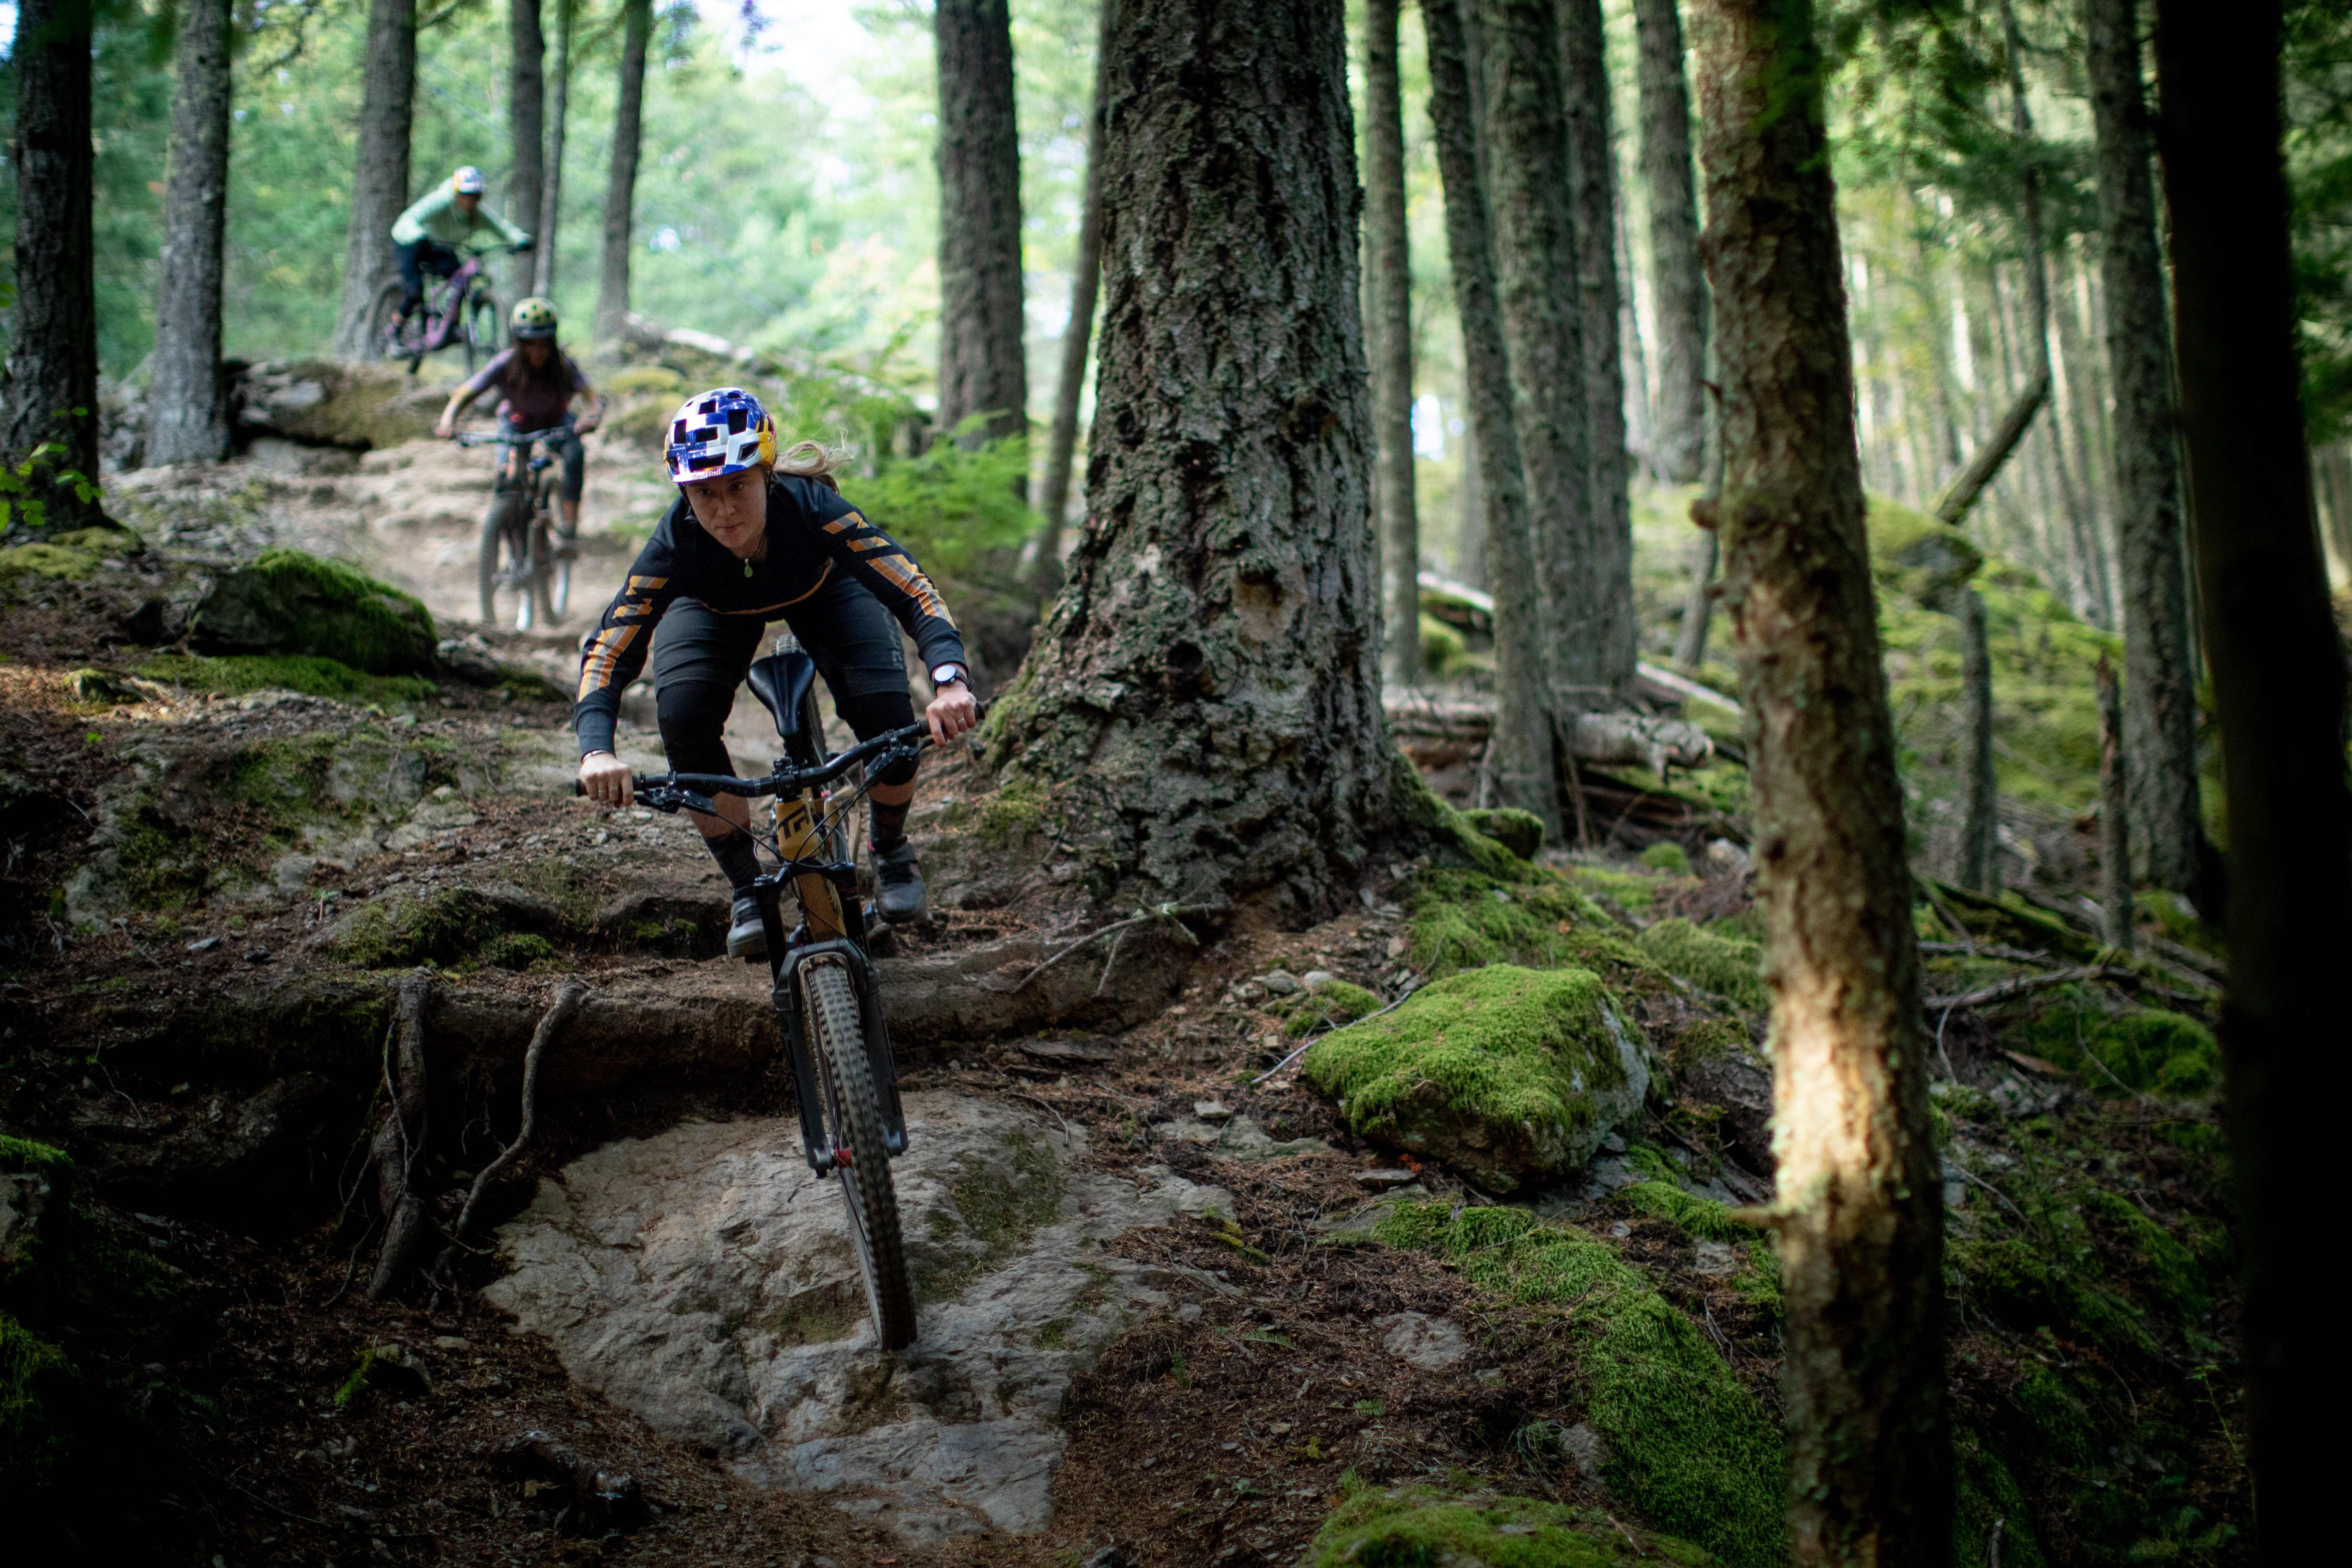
[574,385,979,957]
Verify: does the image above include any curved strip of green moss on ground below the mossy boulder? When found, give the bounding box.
[1373,1204,1785,1568]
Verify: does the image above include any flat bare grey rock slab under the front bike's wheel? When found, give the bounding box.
[484,1093,1232,1545]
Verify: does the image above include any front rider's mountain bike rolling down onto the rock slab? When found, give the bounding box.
[583,649,950,1349]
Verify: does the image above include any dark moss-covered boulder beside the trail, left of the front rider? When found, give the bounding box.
[188,550,437,675]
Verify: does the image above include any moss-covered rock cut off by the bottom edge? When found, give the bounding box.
[1305,1483,1719,1568]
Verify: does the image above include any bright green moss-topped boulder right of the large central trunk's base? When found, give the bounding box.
[1303,964,1649,1192]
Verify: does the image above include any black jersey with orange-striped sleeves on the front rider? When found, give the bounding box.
[572,475,967,757]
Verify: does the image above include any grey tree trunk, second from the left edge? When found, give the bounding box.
[146,0,230,463]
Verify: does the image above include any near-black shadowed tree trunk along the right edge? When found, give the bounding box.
[2157,0,2352,1566]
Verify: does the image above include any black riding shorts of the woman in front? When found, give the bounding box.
[649,573,915,785]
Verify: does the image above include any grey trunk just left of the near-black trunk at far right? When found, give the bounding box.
[2084,0,2218,893]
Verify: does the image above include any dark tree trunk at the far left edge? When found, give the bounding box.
[0,0,99,529]
